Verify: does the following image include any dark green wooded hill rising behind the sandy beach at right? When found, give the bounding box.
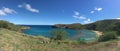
[84,19,120,35]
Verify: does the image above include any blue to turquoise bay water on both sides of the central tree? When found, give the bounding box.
[23,25,96,40]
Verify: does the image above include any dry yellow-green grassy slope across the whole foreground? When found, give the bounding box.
[0,29,120,51]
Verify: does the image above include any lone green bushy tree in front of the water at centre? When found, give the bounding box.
[52,30,67,40]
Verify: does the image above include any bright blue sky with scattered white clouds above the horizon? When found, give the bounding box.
[0,0,120,25]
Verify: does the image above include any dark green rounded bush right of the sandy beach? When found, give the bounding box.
[98,31,117,41]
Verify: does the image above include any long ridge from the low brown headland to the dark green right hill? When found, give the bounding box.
[53,19,120,35]
